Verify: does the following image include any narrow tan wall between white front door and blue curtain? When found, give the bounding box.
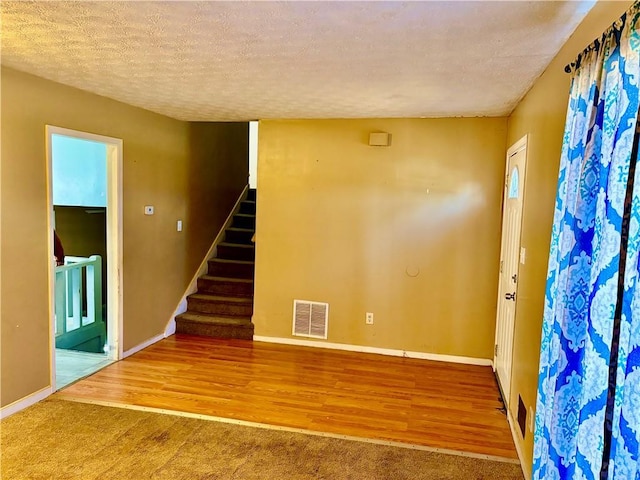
[508,1,631,469]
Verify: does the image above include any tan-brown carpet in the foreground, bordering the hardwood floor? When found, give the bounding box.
[0,399,523,480]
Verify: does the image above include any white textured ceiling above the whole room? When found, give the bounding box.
[1,0,594,121]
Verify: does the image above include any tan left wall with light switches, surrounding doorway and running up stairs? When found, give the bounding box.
[0,69,248,405]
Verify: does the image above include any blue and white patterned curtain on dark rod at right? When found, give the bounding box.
[533,3,640,480]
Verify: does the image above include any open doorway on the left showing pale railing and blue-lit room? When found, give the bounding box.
[46,126,122,390]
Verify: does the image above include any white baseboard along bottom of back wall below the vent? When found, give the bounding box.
[253,335,492,366]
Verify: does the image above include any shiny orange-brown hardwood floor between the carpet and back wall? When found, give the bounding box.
[56,335,517,459]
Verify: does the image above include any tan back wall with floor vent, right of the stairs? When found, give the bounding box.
[254,118,507,359]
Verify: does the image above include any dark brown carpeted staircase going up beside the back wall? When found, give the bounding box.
[176,189,256,340]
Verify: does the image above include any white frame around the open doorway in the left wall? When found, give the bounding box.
[46,125,123,391]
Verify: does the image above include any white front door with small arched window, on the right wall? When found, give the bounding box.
[493,137,527,404]
